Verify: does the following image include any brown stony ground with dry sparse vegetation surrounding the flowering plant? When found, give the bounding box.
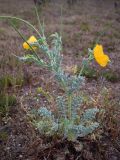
[0,0,120,160]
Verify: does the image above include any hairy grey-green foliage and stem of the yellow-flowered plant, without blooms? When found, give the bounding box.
[20,33,99,140]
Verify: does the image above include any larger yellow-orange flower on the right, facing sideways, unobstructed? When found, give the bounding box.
[93,44,110,67]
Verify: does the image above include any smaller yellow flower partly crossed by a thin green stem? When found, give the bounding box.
[23,36,37,50]
